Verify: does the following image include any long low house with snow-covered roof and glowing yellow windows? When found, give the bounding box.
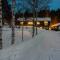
[15,17,51,29]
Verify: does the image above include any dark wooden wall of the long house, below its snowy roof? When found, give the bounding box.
[16,21,50,29]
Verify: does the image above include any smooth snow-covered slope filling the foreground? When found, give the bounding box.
[0,29,60,60]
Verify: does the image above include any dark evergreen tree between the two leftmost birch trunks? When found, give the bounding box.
[2,0,12,25]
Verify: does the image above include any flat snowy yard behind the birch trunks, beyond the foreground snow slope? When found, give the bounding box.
[2,27,32,48]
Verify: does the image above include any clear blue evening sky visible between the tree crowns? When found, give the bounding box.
[8,0,60,12]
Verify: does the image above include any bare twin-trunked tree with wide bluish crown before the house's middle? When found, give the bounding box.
[27,0,50,37]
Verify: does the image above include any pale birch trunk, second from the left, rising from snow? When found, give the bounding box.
[11,0,15,44]
